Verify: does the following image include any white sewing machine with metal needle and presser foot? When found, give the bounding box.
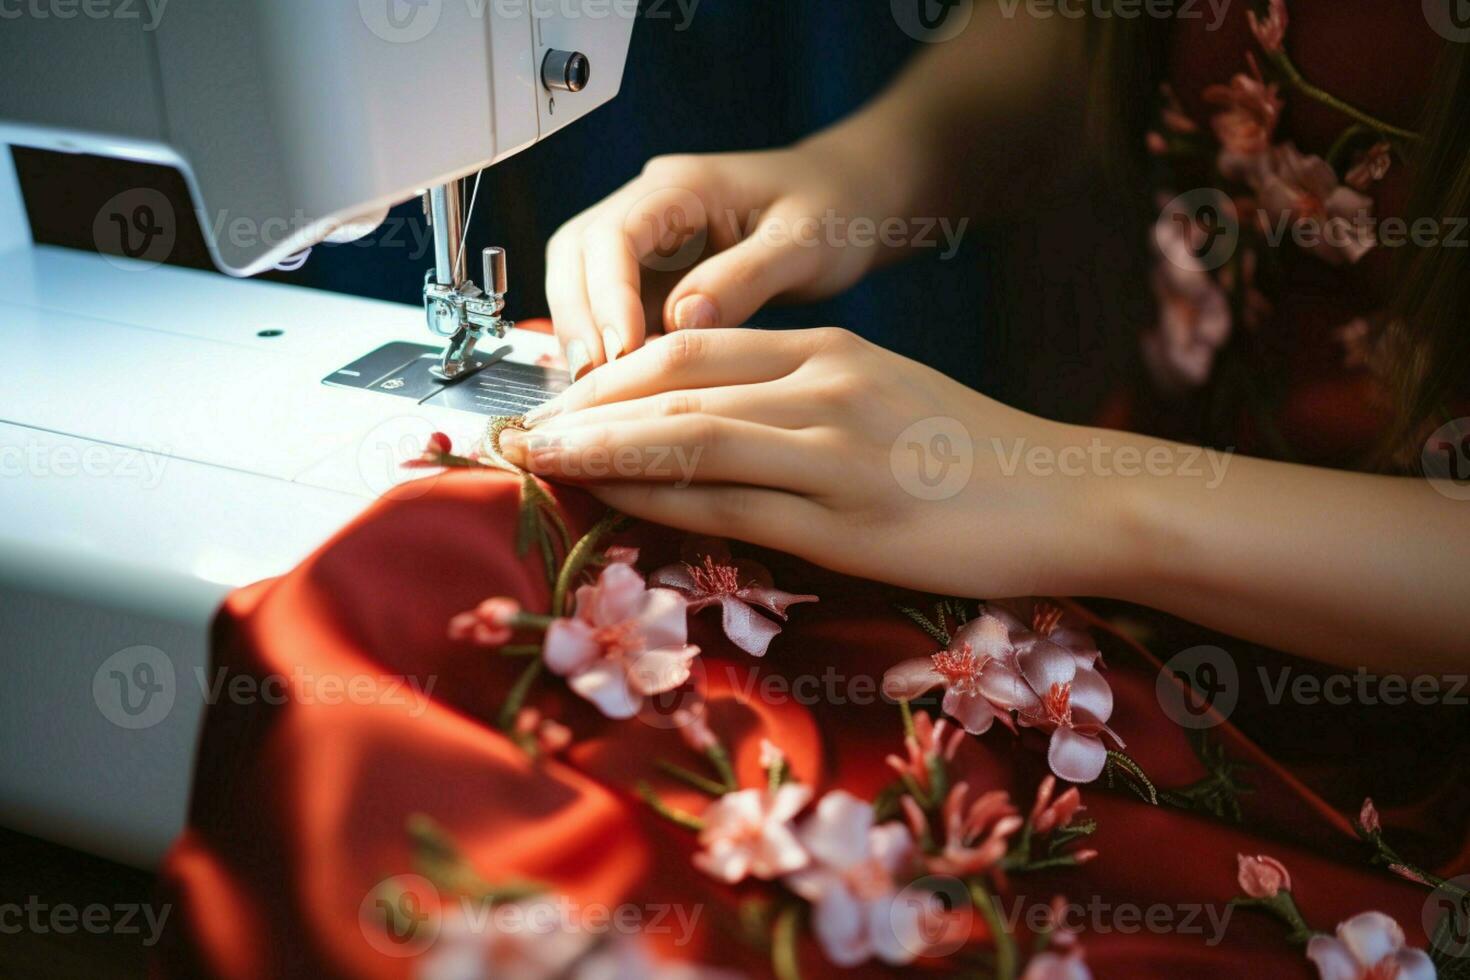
[0,0,637,867]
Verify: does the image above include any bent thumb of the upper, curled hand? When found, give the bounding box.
[663,202,822,331]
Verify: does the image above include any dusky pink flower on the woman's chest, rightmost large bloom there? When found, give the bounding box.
[1255,143,1377,266]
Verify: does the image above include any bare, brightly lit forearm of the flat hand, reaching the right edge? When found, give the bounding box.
[1092,432,1470,671]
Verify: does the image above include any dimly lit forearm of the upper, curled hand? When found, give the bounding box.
[806,3,1086,219]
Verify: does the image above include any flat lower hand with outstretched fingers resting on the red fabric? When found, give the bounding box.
[501,329,1128,597]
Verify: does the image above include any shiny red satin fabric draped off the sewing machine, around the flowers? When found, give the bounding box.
[154,472,1446,979]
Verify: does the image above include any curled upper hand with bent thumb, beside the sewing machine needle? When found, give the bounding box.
[547,132,897,378]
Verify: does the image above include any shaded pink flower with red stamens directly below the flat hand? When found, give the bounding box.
[650,541,817,657]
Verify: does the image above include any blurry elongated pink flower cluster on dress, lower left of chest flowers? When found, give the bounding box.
[1144,196,1230,392]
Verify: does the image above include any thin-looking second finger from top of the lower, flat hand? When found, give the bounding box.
[535,381,819,433]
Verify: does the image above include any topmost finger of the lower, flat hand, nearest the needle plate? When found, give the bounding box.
[526,331,811,425]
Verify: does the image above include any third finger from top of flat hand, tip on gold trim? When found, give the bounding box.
[500,416,832,494]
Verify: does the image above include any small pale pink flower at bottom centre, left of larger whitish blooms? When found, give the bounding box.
[694,783,811,884]
